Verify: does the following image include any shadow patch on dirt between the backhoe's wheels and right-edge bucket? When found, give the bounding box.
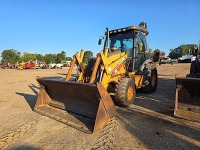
[134,78,176,116]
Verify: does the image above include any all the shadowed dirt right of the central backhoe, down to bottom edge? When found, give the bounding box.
[116,78,200,149]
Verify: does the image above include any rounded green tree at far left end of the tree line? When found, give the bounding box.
[1,49,20,63]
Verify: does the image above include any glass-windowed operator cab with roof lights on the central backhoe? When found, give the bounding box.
[101,26,148,70]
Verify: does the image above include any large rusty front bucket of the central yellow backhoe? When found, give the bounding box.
[34,77,115,133]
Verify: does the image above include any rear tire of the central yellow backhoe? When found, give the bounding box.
[139,68,158,93]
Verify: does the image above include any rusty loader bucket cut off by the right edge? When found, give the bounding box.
[174,77,200,122]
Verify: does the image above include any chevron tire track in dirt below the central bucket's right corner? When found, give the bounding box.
[91,117,119,150]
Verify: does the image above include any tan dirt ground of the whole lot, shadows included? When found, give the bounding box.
[0,64,200,150]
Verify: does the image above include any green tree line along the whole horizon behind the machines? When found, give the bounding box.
[1,44,197,64]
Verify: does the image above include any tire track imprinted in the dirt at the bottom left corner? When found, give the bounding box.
[0,122,37,149]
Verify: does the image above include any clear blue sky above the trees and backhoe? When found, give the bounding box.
[0,0,200,57]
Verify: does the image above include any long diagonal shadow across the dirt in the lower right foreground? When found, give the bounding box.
[116,107,200,149]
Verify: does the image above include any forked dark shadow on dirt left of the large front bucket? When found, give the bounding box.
[16,84,40,110]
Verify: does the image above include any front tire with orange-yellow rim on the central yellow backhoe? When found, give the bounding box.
[115,78,136,107]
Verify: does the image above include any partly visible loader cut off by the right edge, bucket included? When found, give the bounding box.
[174,47,200,122]
